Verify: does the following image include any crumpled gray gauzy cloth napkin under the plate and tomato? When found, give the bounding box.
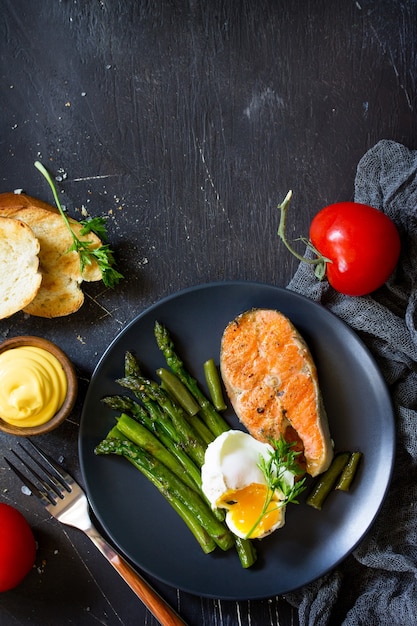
[286,140,417,626]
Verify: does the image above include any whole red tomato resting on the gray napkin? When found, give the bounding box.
[310,202,400,296]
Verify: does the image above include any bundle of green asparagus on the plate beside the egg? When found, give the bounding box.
[95,322,256,568]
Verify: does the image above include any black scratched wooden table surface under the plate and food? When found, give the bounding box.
[0,0,417,626]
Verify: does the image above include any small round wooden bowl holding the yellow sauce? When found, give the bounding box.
[0,335,78,437]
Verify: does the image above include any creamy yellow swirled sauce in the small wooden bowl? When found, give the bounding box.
[0,346,68,427]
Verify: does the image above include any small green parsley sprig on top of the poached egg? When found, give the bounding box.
[246,436,306,538]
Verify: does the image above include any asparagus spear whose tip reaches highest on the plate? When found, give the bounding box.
[154,322,230,437]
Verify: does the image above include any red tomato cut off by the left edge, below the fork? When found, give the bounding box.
[0,503,36,592]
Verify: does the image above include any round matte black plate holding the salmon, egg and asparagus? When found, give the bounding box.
[79,282,394,600]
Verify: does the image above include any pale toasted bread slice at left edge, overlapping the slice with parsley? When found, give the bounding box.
[0,217,42,319]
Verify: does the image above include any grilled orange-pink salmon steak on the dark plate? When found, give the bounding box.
[220,309,333,476]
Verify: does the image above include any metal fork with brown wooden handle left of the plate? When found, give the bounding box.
[4,439,186,626]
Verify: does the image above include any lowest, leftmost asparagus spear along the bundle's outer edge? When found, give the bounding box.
[95,439,234,550]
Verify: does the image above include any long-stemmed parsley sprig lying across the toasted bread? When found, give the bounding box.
[35,161,123,287]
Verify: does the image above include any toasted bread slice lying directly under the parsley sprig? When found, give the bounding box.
[0,193,101,317]
